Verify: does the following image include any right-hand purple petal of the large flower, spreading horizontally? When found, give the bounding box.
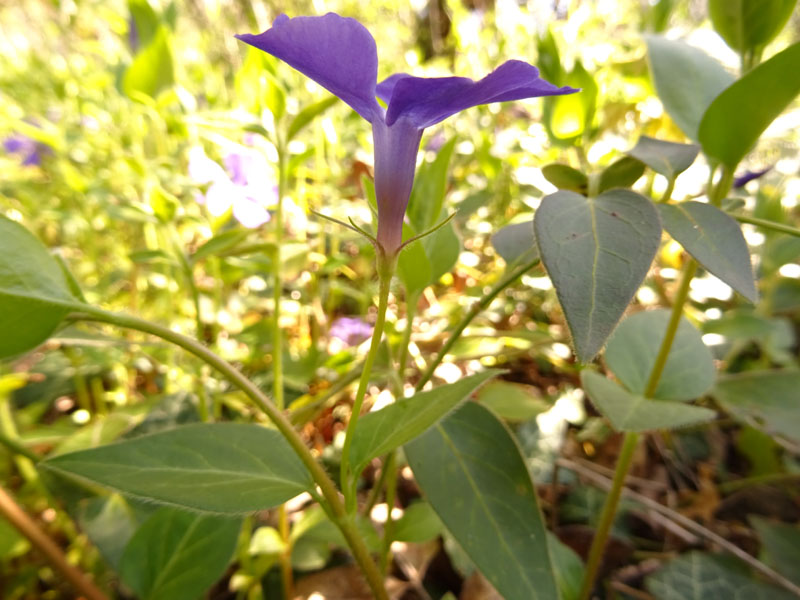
[379,60,579,128]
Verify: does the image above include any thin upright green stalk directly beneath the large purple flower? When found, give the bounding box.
[340,266,394,514]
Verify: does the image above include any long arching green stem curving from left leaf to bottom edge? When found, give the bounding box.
[69,305,388,600]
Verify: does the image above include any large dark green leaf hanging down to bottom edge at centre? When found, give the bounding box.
[405,402,558,600]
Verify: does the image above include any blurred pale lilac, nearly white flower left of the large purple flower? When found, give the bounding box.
[189,146,278,229]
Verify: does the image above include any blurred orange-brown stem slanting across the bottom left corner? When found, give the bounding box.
[0,486,108,600]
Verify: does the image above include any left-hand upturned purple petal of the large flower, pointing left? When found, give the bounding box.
[236,13,381,121]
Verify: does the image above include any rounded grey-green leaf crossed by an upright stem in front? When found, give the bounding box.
[605,309,716,401]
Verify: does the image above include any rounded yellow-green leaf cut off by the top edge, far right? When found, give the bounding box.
[708,0,797,52]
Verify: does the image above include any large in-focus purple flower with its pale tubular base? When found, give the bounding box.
[236,13,577,256]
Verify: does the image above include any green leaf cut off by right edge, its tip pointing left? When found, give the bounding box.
[711,371,800,442]
